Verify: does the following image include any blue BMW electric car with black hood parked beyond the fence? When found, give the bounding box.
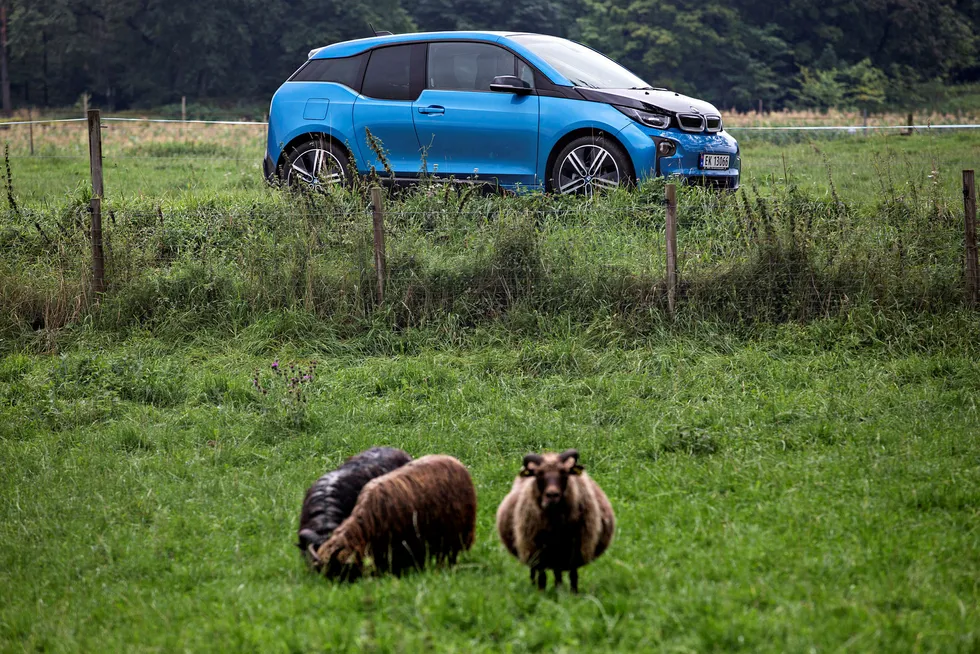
[264,32,741,195]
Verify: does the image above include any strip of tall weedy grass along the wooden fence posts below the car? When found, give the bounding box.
[0,163,961,356]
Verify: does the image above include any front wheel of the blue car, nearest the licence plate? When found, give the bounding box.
[548,132,634,196]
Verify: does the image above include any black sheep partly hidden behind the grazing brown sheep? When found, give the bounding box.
[297,447,412,564]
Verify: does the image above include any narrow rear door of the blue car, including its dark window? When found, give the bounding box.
[352,43,425,177]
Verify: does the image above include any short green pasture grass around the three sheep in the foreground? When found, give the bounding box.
[0,314,980,652]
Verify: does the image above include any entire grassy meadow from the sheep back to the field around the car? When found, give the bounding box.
[0,115,980,652]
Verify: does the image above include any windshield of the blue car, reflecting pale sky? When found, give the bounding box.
[510,34,650,89]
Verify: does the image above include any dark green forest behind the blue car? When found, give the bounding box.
[3,0,980,118]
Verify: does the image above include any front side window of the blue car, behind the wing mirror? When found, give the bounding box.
[426,42,534,91]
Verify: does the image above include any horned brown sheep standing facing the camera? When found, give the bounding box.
[497,450,616,593]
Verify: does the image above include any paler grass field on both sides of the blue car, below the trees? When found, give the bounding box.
[7,123,980,207]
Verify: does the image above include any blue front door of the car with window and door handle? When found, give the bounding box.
[414,41,538,184]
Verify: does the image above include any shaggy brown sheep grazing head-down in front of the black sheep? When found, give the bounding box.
[313,454,476,581]
